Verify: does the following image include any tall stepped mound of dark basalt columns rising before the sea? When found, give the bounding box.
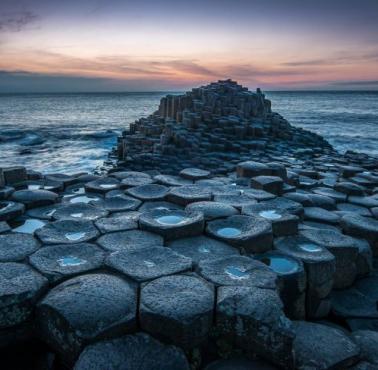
[117,80,332,174]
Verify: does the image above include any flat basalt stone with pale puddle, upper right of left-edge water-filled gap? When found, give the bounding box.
[52,203,108,221]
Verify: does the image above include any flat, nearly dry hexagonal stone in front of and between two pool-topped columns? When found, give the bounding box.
[168,235,239,265]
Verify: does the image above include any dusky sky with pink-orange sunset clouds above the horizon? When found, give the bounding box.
[0,0,378,92]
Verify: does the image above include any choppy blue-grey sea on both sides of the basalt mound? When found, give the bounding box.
[0,92,378,173]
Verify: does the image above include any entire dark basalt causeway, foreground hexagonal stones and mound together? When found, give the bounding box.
[0,80,378,370]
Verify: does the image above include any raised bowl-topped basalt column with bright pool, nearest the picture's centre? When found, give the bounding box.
[139,209,204,240]
